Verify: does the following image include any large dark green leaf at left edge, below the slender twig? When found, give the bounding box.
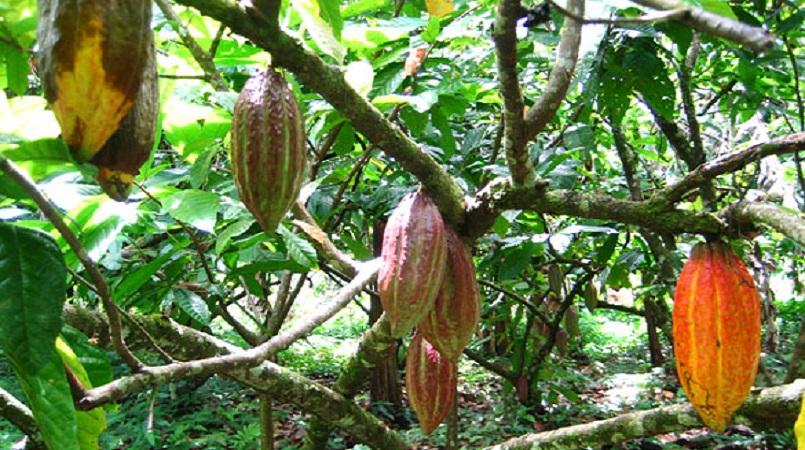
[0,223,67,374]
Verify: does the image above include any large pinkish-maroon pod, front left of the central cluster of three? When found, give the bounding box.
[377,192,447,338]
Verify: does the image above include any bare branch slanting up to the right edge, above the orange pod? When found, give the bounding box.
[651,132,805,204]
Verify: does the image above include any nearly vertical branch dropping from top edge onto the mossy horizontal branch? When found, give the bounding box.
[492,0,537,186]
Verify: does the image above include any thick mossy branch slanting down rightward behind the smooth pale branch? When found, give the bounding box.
[64,305,408,450]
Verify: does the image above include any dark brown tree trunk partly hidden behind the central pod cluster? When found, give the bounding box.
[369,219,402,409]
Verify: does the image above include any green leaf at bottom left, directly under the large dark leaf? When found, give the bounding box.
[12,352,81,450]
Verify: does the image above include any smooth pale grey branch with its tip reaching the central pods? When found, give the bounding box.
[78,260,380,409]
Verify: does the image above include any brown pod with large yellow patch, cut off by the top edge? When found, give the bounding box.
[37,0,152,162]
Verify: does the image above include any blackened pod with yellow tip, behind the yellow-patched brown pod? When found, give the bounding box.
[91,30,159,201]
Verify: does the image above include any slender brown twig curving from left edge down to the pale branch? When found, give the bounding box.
[0,154,144,372]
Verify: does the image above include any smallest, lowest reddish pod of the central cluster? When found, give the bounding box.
[405,333,458,434]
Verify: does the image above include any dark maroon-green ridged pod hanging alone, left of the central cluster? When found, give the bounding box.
[230,67,305,233]
